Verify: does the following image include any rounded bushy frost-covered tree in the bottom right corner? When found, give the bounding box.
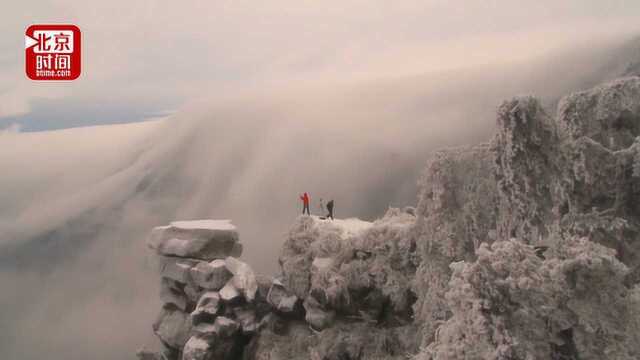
[417,238,640,360]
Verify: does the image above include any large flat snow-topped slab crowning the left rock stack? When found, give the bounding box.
[147,220,242,260]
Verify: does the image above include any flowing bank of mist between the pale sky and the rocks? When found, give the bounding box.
[0,31,638,360]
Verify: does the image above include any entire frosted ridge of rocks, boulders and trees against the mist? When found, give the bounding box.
[139,77,640,360]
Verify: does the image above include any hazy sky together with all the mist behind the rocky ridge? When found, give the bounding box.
[0,0,640,360]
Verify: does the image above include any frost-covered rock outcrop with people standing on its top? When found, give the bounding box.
[262,209,418,360]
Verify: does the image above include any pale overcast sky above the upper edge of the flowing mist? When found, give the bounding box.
[0,0,640,131]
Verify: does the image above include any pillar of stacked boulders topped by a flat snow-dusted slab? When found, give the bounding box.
[138,220,270,360]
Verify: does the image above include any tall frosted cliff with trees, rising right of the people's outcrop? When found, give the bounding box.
[414,77,640,360]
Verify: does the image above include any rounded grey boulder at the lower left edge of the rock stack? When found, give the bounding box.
[153,306,191,349]
